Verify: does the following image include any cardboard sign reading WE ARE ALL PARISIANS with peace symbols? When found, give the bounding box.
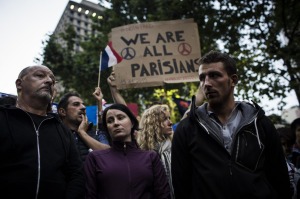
[111,19,201,89]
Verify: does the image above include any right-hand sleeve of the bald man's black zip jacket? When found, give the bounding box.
[65,128,85,199]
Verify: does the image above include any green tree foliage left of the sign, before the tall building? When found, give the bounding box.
[42,26,111,105]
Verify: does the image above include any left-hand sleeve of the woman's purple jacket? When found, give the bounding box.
[84,152,97,199]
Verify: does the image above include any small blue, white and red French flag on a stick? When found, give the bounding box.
[100,41,123,71]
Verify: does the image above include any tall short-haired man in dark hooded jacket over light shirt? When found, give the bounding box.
[171,51,291,199]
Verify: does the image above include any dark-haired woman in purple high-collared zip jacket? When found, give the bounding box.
[84,104,170,199]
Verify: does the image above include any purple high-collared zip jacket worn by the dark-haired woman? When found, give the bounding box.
[84,141,170,199]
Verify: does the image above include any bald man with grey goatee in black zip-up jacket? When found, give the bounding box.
[0,66,85,199]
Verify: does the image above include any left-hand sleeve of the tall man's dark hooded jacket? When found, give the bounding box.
[171,118,192,199]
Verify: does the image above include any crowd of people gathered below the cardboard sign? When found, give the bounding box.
[0,51,300,199]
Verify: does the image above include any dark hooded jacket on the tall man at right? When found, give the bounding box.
[171,97,291,199]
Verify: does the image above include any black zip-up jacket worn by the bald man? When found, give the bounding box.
[0,106,84,199]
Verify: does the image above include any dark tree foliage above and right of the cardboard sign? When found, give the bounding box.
[100,0,300,111]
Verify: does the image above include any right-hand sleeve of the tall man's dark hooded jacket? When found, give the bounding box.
[261,117,292,199]
